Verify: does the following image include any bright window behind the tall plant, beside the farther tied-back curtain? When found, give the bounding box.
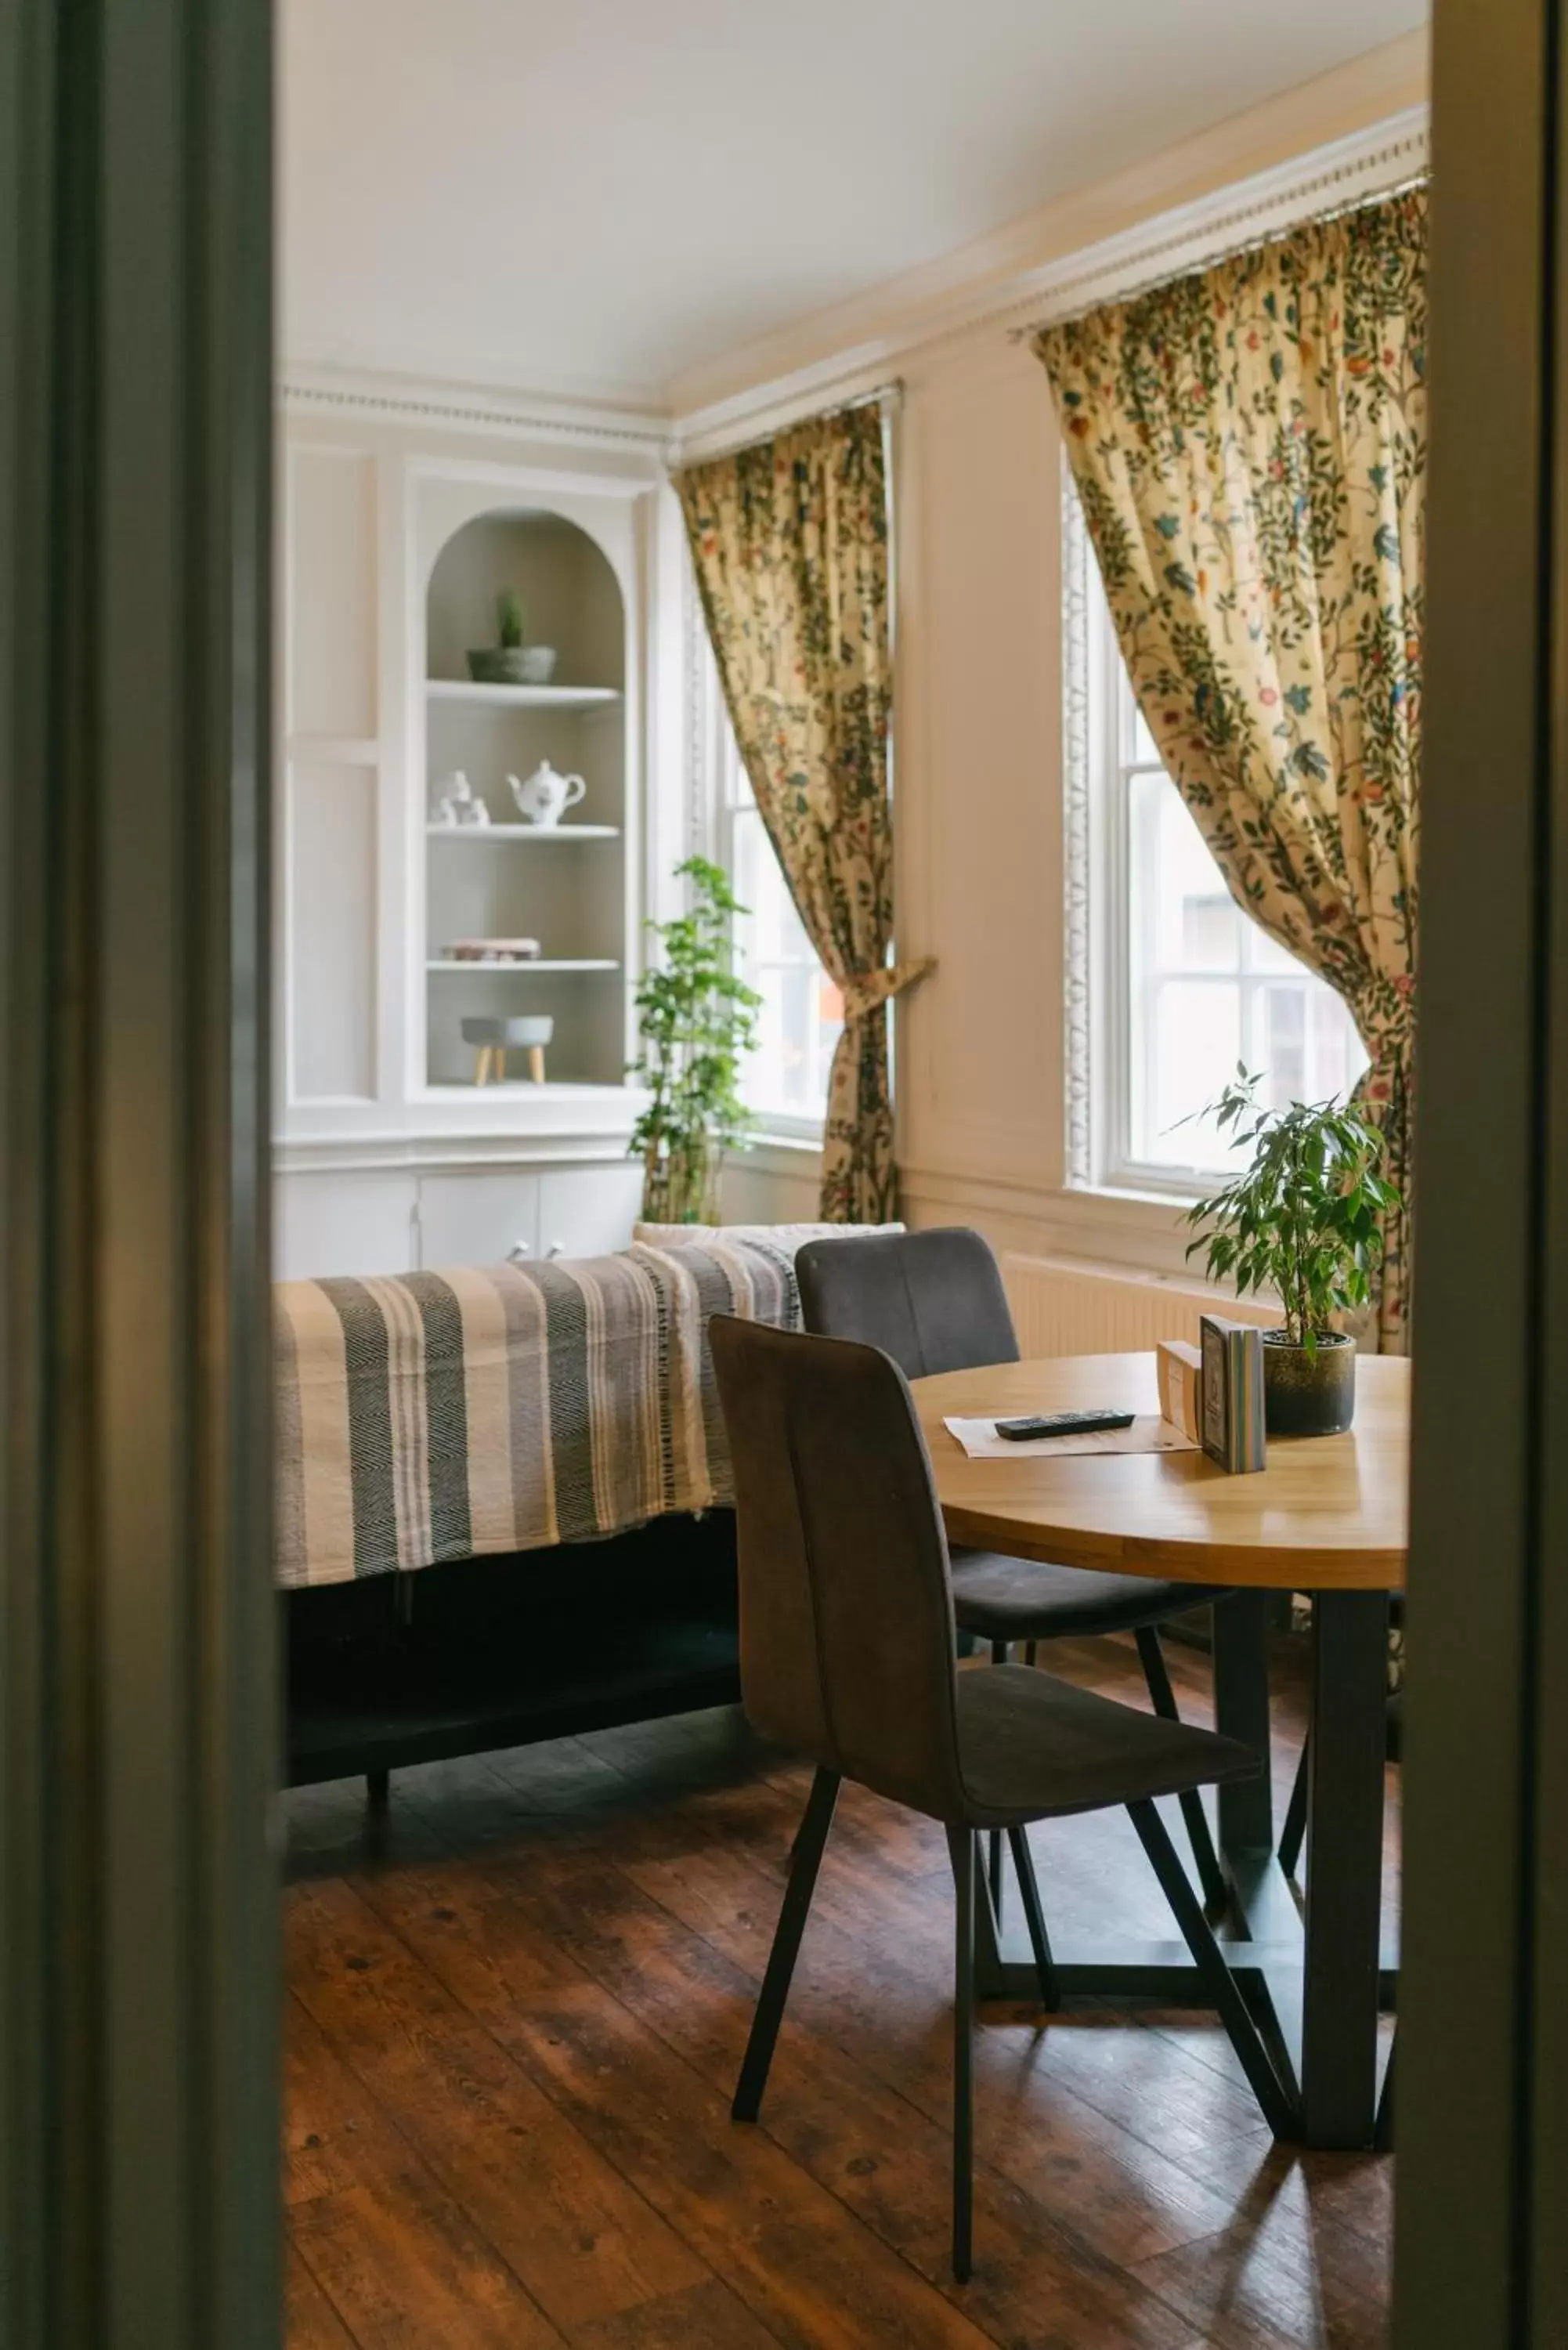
[712,700,844,1135]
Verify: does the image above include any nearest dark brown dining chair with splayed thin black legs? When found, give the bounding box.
[710,1316,1291,2280]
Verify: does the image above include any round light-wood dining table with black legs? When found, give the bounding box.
[915,1354,1411,2148]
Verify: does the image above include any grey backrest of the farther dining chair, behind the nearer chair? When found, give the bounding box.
[795,1227,1018,1379]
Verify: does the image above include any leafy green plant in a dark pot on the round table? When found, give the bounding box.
[1185,1062,1401,1436]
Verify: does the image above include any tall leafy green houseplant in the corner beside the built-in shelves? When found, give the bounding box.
[632,858,761,1224]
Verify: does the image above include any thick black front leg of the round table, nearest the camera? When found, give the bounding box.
[1302,1591,1389,2148]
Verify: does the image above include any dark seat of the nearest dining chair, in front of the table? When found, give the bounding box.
[957,1664,1258,1828]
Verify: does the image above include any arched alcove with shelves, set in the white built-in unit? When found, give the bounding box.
[425,508,627,1088]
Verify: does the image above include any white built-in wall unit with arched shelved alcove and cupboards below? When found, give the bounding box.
[275,409,684,1276]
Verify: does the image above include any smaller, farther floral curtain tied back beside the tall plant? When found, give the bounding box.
[674,407,931,1224]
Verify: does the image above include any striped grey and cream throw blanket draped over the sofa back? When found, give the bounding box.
[275,1241,800,1586]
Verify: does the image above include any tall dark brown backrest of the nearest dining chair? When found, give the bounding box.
[707,1325,962,1819]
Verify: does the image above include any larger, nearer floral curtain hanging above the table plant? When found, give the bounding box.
[1035,188,1427,1351]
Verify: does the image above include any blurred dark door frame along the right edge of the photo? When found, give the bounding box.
[1394,0,1568,2350]
